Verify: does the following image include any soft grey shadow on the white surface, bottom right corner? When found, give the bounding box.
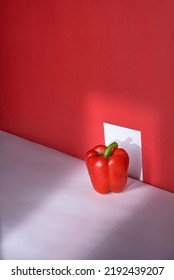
[84,188,174,260]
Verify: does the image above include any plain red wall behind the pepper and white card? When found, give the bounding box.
[0,0,174,191]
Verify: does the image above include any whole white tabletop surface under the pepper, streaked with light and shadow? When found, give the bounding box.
[0,131,174,259]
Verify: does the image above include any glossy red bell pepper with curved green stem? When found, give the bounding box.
[85,142,129,194]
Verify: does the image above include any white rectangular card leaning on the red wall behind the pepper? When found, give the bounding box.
[104,123,143,181]
